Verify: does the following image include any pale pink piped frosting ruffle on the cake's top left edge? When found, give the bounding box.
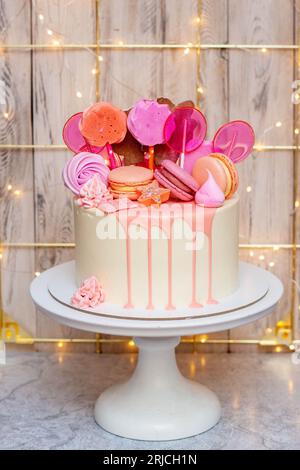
[78,174,113,209]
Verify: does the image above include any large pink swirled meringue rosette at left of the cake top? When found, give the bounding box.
[62,152,109,196]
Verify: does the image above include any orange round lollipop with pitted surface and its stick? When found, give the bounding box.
[79,102,127,169]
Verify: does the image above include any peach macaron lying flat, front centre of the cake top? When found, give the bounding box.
[108,165,153,201]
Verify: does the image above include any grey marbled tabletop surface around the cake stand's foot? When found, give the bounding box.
[0,352,300,450]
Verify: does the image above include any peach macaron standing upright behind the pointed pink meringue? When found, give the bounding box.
[192,153,239,199]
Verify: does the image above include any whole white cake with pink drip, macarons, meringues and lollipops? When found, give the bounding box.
[63,100,254,315]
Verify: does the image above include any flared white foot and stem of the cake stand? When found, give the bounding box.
[95,337,221,441]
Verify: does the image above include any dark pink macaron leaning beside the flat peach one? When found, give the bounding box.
[154,160,199,201]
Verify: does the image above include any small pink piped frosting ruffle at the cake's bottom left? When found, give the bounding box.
[71,276,105,308]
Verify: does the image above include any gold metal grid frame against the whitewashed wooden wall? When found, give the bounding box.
[0,0,300,352]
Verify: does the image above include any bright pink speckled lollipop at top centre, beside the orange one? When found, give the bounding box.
[127,100,170,170]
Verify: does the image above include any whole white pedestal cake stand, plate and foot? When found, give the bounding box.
[31,263,283,441]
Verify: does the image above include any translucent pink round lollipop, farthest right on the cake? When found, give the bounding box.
[213,121,255,163]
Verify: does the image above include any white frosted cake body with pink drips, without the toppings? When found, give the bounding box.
[75,196,239,310]
